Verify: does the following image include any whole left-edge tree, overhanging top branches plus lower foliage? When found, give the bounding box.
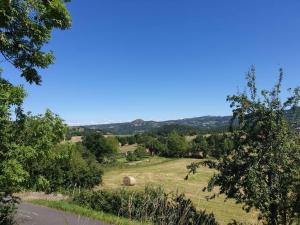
[0,0,71,225]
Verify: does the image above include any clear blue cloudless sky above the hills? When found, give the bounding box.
[4,0,300,124]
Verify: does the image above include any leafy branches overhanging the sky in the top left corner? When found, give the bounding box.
[0,0,71,84]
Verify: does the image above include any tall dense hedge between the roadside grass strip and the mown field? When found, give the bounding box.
[73,186,218,225]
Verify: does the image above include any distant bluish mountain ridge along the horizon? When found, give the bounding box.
[77,107,300,134]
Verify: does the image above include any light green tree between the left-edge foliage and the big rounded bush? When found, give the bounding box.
[15,110,67,188]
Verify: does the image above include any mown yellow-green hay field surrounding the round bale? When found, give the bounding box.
[98,157,257,224]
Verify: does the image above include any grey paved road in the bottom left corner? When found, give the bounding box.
[17,203,108,225]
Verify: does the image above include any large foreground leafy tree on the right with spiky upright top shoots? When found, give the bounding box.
[189,68,300,225]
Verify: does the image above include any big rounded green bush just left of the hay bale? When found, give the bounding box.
[41,143,103,191]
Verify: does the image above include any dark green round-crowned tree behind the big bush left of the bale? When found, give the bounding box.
[82,133,119,163]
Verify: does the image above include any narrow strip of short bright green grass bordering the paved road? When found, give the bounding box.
[28,200,151,225]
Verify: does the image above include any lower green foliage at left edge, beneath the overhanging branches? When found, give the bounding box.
[0,79,28,194]
